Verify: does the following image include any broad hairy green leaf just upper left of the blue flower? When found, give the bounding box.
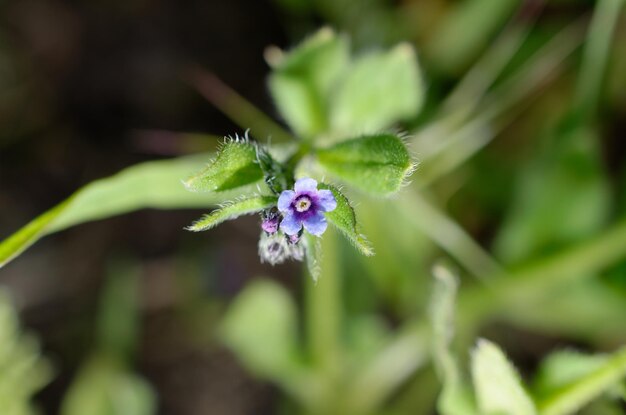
[184,137,263,192]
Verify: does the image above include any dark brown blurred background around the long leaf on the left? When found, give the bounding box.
[0,0,287,414]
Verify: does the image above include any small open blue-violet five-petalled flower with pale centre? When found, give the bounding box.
[278,177,337,236]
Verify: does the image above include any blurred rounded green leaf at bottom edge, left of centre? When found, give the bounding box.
[60,355,156,415]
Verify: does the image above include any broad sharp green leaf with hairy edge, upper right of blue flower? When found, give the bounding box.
[317,134,415,195]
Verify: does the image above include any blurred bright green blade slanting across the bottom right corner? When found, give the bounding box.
[539,348,626,415]
